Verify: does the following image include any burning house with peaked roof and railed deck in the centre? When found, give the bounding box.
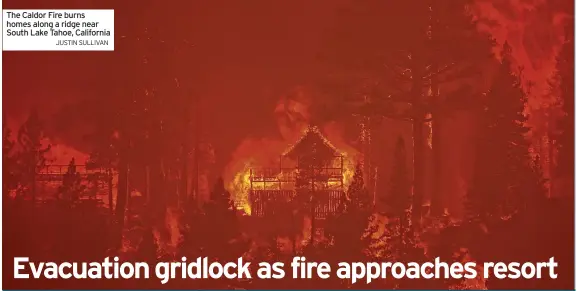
[248,126,352,219]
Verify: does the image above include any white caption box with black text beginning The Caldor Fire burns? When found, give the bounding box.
[2,9,114,51]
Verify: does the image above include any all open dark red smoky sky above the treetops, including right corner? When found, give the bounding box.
[3,0,573,173]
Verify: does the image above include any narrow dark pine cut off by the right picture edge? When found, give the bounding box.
[556,22,575,180]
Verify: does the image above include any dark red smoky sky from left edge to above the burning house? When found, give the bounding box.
[3,0,352,161]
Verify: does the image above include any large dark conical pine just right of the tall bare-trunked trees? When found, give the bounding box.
[466,43,531,220]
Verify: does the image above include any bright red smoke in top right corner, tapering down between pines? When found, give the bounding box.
[476,0,574,196]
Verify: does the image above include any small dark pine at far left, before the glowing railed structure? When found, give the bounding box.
[18,109,50,200]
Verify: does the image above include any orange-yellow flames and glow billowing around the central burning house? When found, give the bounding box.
[223,87,360,215]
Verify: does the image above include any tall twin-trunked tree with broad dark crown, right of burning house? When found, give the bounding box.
[328,0,492,226]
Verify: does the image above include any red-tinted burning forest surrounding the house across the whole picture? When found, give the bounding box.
[2,0,575,289]
